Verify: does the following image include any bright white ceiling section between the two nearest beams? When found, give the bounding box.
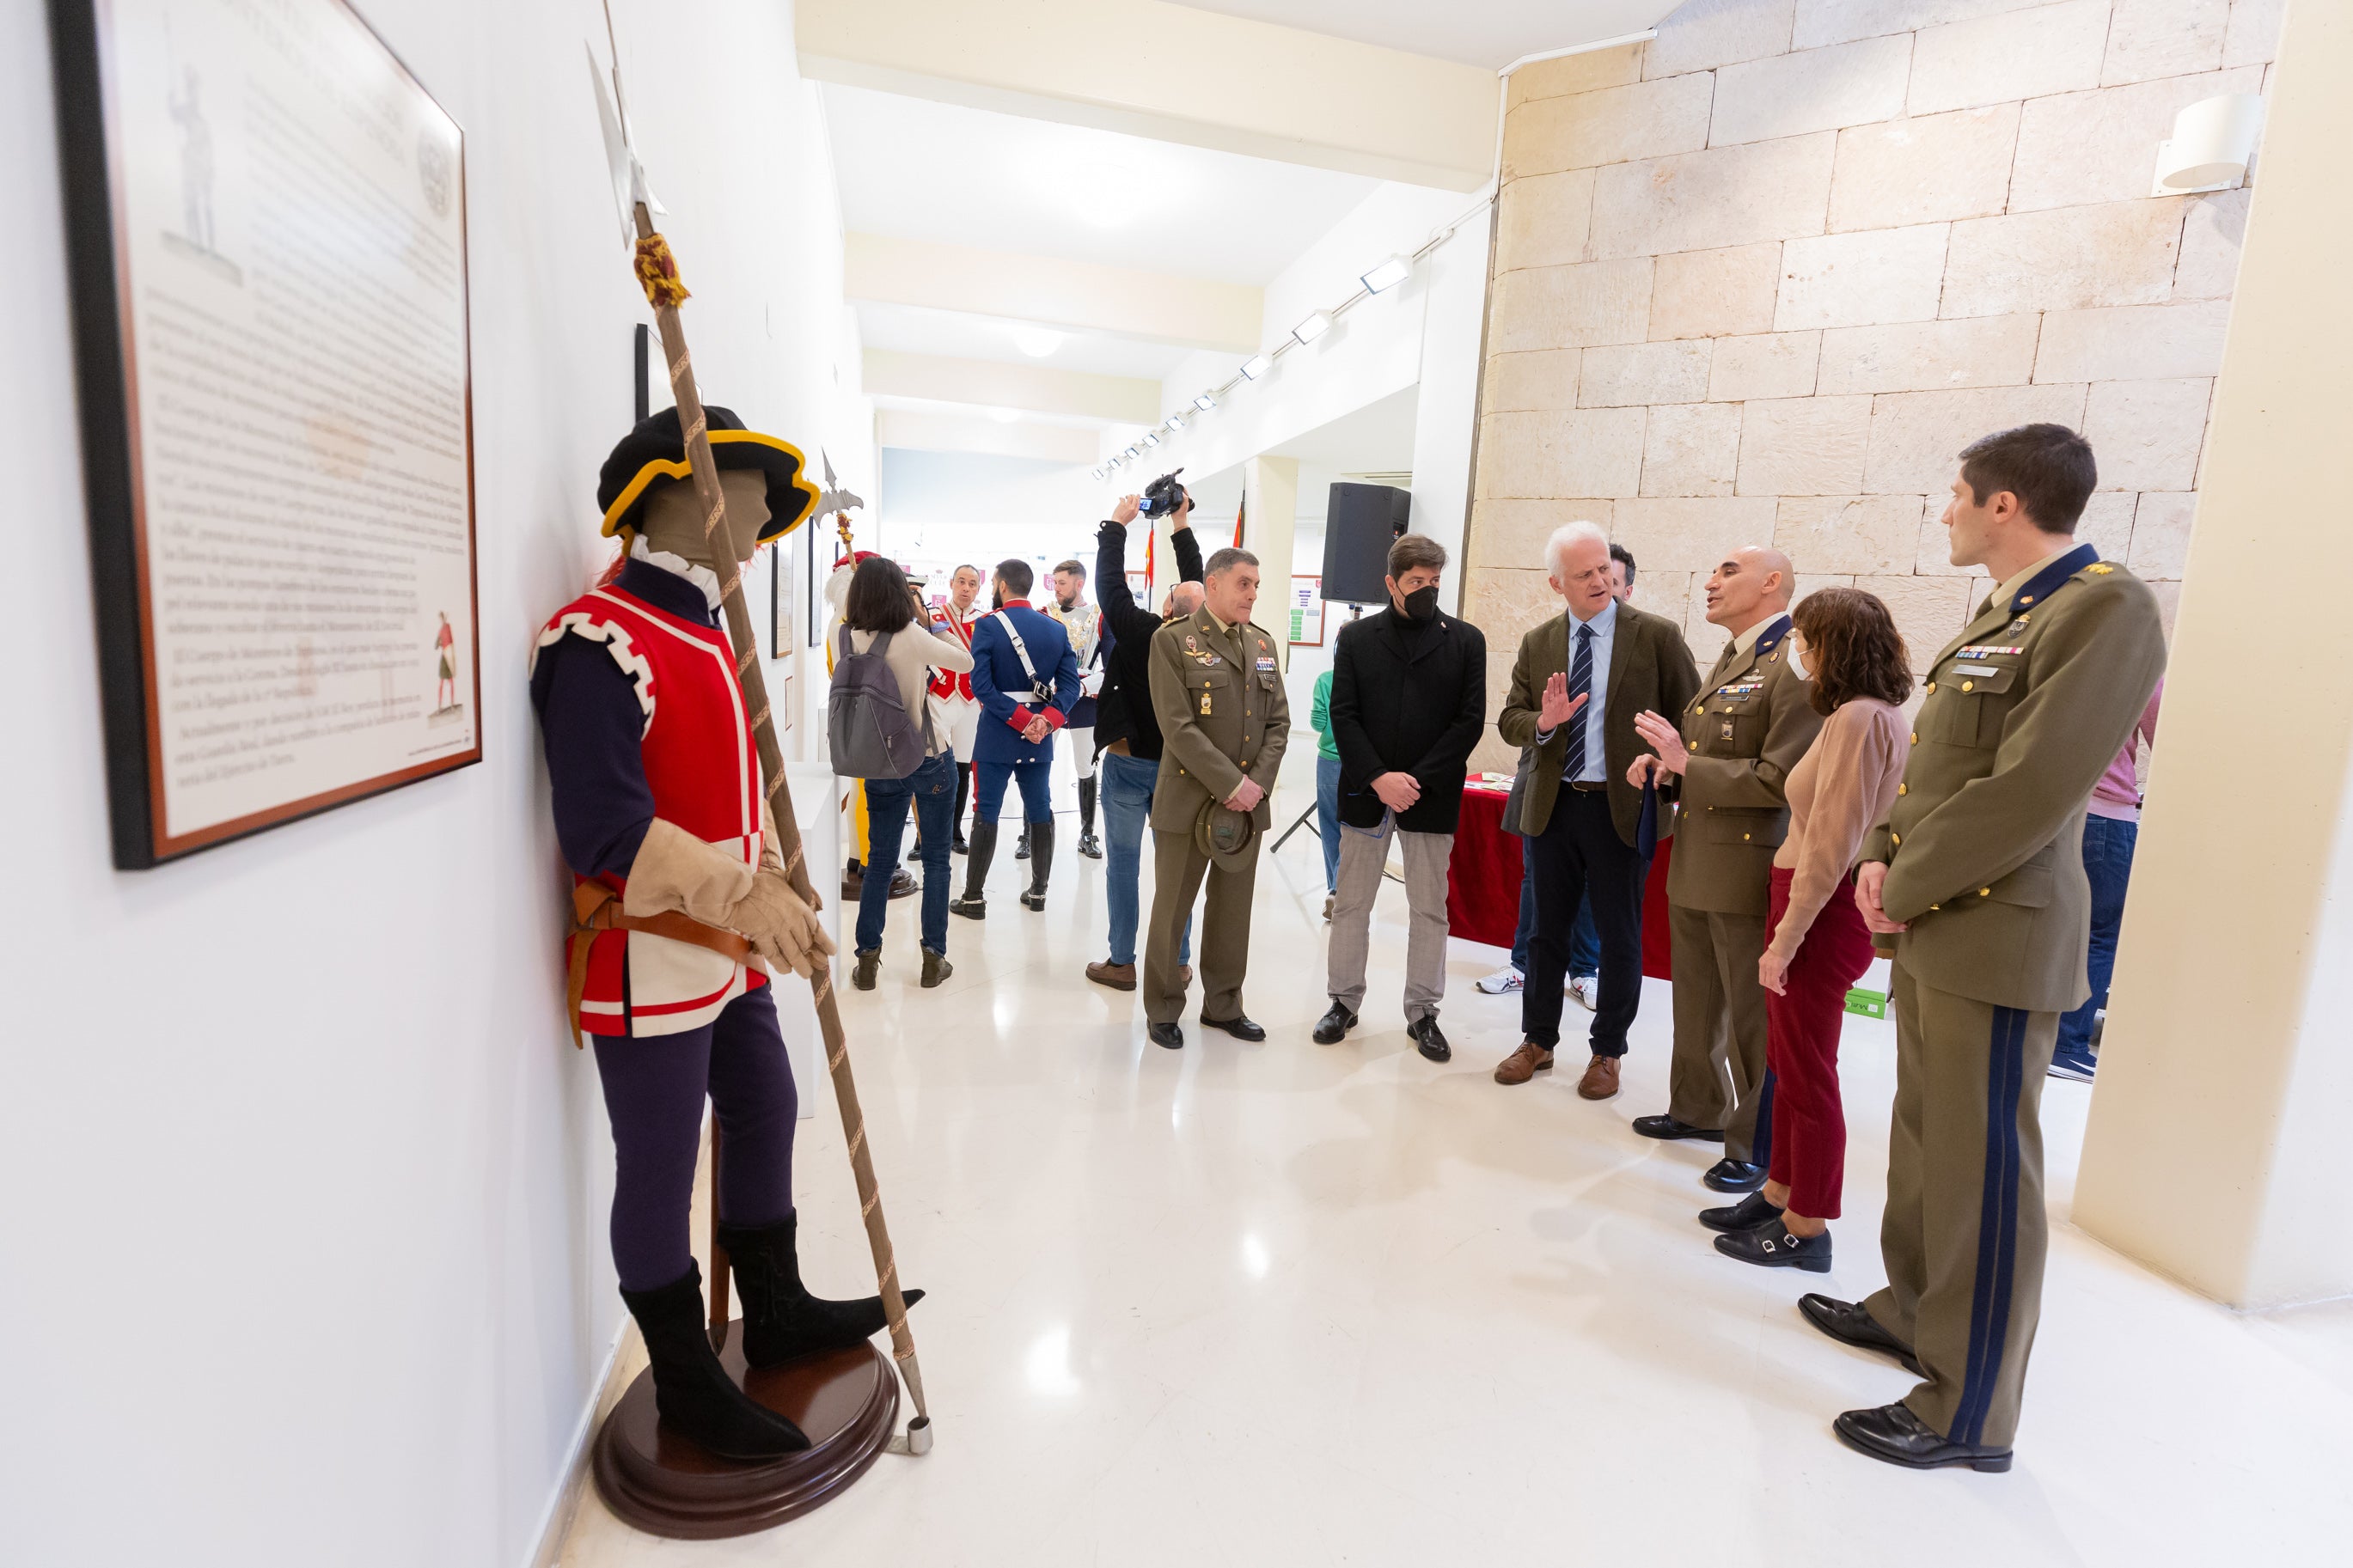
[823,85,1378,284]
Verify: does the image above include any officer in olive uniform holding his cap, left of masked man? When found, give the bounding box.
[1144,550,1292,1051]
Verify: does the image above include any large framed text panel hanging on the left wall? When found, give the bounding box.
[49,0,482,869]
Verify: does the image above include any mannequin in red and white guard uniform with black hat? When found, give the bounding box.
[532,406,920,1460]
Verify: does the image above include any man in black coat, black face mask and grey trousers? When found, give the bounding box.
[1316,534,1487,1063]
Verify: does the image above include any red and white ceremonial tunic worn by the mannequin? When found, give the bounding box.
[532,588,767,1037]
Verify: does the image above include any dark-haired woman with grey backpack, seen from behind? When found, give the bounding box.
[835,555,972,990]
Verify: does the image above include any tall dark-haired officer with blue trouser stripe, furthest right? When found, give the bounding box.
[1798,425,2165,1469]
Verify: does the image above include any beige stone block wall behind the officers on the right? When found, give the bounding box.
[1464,0,2283,769]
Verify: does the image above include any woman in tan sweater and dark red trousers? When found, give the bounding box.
[1699,588,1910,1274]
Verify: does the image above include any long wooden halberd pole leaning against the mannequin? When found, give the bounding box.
[638,202,932,1427]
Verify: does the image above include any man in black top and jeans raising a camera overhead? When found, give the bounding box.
[1087,491,1200,992]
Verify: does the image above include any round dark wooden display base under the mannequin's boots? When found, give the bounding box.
[593,1319,899,1540]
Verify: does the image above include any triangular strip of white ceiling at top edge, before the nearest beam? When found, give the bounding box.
[1158,0,1680,70]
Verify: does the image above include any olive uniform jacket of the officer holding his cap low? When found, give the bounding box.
[1151,609,1292,833]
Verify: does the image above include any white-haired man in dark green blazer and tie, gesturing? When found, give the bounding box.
[1494,522,1699,1101]
